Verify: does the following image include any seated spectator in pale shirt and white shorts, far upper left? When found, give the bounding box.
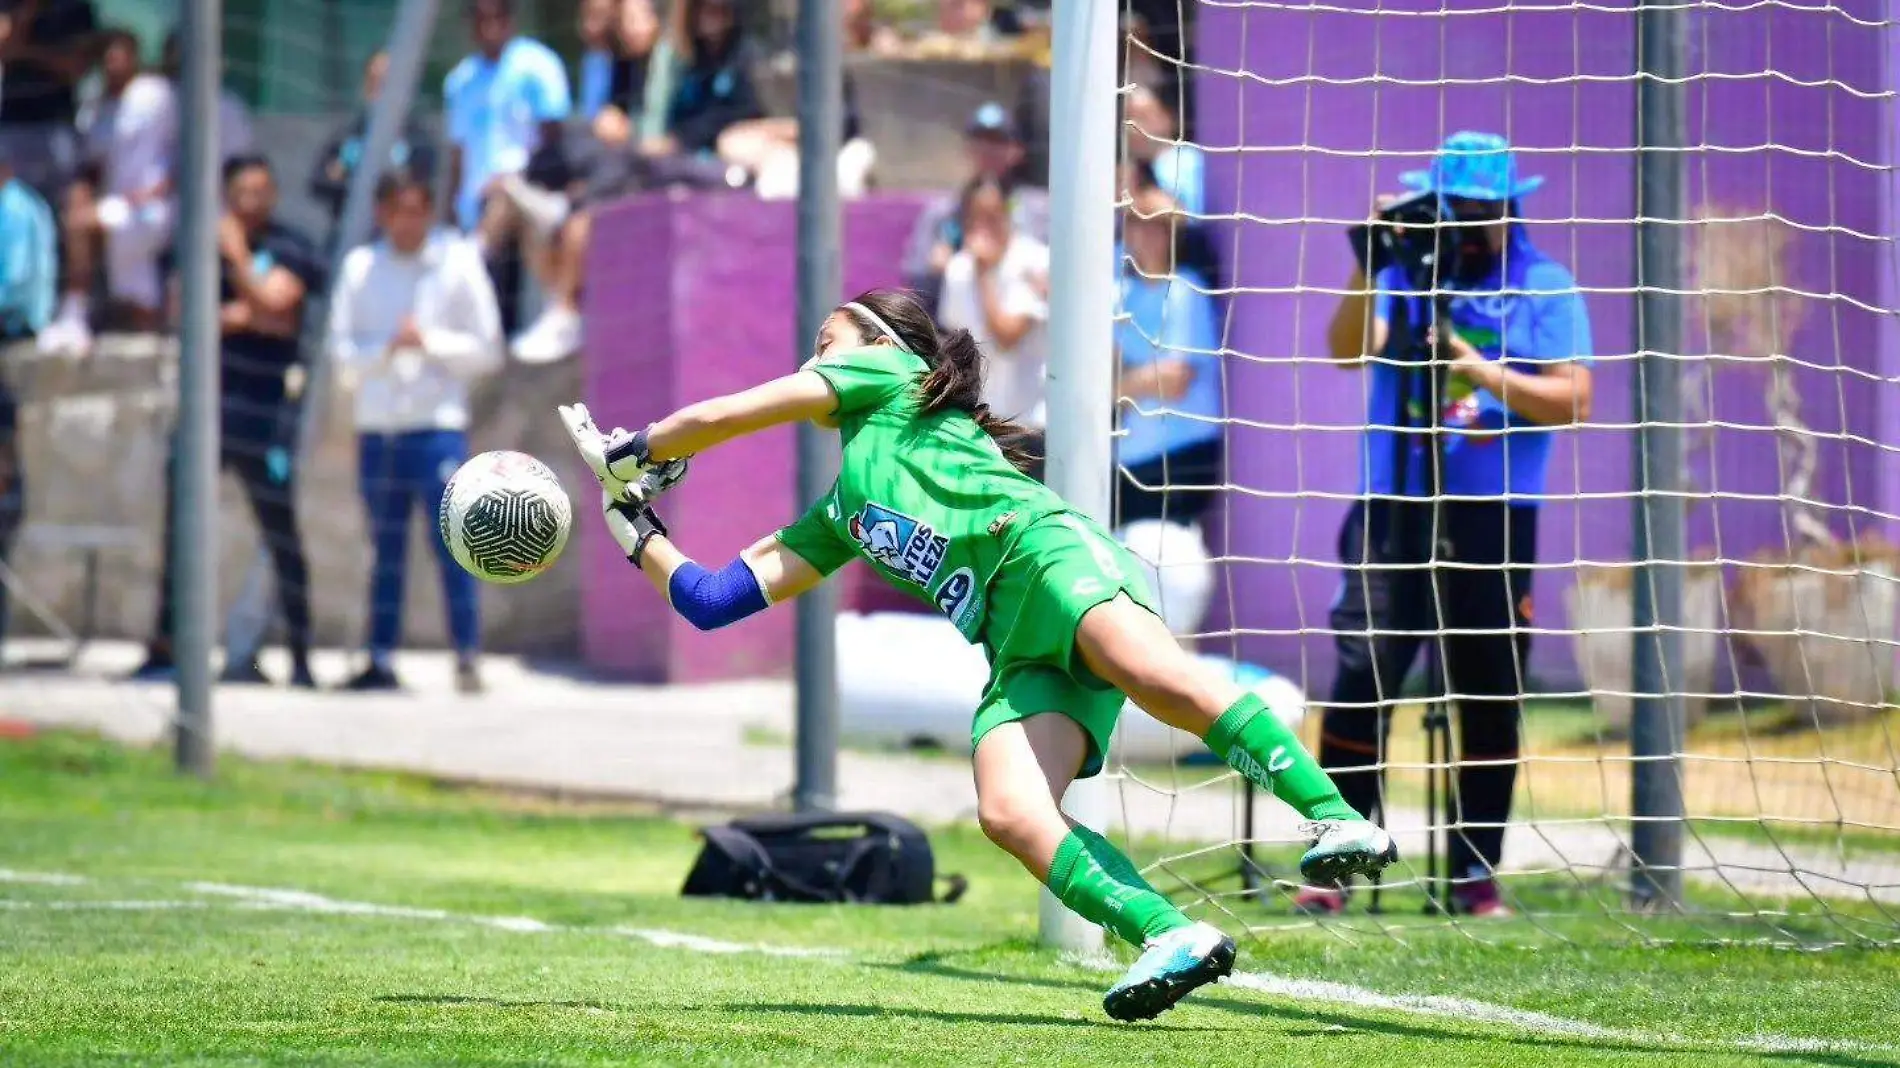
[40,30,179,355]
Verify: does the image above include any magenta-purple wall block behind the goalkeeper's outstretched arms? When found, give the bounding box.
[578,194,920,682]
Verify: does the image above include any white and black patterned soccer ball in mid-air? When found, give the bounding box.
[435,450,574,585]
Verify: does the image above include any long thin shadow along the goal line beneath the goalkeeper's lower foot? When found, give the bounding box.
[865,943,1894,1068]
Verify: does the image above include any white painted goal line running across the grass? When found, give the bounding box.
[0,868,1900,1053]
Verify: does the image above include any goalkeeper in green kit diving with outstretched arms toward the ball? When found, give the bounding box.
[561,289,1397,1020]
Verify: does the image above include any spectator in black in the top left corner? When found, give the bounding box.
[0,0,99,203]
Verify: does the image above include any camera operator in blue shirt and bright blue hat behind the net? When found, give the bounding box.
[1296,133,1590,916]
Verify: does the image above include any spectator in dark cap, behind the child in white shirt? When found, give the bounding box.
[903,101,1049,308]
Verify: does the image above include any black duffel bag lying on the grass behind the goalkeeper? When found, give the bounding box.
[680,811,967,905]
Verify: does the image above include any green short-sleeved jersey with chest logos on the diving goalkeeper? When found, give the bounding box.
[779,346,1068,642]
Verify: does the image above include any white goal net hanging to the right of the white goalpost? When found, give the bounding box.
[1113,0,1900,944]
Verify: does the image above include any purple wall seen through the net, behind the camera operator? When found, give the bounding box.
[1197,0,1900,688]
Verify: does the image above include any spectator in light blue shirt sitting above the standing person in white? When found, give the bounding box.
[443,0,574,236]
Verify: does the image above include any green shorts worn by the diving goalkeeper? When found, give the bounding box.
[969,513,1155,779]
